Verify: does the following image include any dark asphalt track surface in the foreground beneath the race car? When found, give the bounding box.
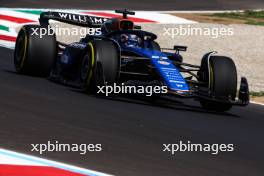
[0,45,264,176]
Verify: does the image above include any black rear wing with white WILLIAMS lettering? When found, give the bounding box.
[39,12,108,27]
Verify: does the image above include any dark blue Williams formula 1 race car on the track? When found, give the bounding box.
[14,10,249,111]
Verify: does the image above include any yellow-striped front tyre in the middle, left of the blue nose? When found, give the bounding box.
[80,40,120,93]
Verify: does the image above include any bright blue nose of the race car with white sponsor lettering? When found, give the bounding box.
[123,46,189,91]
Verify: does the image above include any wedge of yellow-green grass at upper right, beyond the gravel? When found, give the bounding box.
[208,10,264,26]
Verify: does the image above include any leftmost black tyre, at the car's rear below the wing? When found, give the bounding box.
[14,25,57,76]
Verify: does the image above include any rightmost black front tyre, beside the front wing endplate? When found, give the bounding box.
[198,56,237,111]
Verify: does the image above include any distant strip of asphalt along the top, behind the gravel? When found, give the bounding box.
[0,0,264,10]
